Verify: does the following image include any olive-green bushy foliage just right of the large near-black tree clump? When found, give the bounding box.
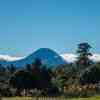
[52,64,79,92]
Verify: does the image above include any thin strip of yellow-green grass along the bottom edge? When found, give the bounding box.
[1,96,100,100]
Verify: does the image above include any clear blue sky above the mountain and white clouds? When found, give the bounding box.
[0,0,100,56]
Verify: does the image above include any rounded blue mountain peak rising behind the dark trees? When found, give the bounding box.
[28,48,66,65]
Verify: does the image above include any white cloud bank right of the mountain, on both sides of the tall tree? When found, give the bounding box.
[61,53,100,63]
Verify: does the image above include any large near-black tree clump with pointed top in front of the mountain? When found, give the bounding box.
[9,57,51,89]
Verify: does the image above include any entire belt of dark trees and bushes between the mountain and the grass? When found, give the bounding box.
[0,43,100,100]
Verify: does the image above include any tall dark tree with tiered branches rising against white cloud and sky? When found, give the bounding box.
[76,42,92,67]
